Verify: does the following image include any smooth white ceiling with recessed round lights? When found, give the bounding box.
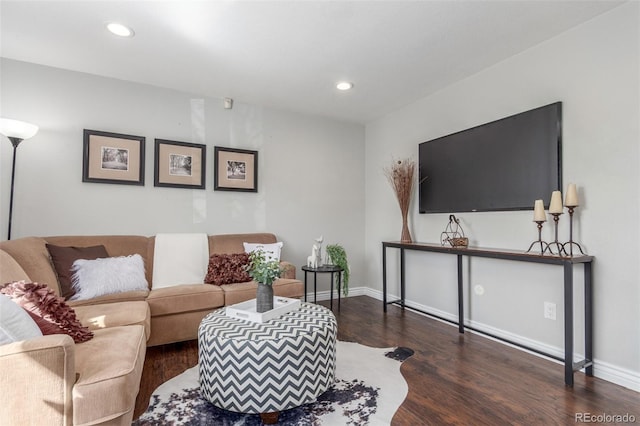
[0,0,623,123]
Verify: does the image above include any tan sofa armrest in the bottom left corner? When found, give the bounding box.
[0,334,76,425]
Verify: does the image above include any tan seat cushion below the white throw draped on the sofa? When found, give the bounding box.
[147,284,224,317]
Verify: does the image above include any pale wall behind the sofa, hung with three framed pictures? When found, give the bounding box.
[0,59,364,290]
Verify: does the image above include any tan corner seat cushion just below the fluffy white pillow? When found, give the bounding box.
[74,301,151,338]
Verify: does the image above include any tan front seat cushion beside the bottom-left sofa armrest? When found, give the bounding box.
[73,325,146,425]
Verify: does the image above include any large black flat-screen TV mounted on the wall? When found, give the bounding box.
[418,102,562,213]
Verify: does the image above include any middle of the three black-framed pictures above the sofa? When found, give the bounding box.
[153,139,207,189]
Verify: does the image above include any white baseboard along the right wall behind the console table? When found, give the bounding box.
[362,287,640,392]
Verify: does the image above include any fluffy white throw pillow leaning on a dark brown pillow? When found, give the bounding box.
[69,254,149,300]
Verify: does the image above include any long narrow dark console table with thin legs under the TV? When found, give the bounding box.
[382,241,594,386]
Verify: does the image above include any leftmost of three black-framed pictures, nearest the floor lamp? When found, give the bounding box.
[82,129,145,185]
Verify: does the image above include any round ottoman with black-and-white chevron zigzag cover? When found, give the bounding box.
[198,303,337,423]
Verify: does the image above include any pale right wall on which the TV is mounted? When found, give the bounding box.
[365,2,640,390]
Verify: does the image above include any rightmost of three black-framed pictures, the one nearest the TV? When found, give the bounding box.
[213,146,258,192]
